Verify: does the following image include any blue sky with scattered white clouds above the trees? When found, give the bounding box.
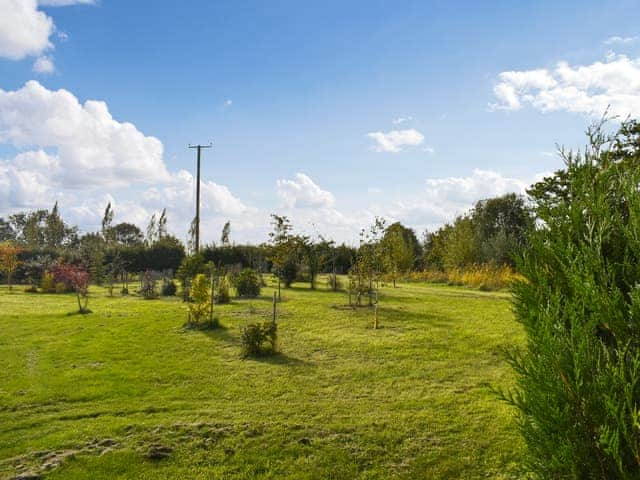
[0,0,640,244]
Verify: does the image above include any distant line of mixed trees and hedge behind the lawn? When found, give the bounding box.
[0,189,534,284]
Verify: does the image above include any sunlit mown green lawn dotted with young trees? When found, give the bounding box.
[0,284,523,479]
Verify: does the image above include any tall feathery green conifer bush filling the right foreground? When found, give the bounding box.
[507,121,640,479]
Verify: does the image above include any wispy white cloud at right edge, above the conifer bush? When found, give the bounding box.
[491,55,640,116]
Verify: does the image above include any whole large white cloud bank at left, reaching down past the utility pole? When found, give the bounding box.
[0,82,255,244]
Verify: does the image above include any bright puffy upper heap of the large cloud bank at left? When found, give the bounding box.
[0,81,168,188]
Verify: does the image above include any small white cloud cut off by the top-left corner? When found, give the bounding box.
[0,0,55,60]
